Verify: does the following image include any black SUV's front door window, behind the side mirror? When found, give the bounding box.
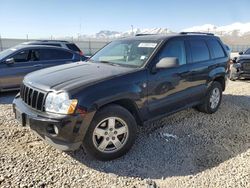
[159,41,186,65]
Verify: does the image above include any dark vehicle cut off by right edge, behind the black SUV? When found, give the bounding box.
[229,48,250,81]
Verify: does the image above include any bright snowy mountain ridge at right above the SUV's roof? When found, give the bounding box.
[183,22,250,36]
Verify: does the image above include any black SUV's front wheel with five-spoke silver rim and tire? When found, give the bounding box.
[83,105,137,160]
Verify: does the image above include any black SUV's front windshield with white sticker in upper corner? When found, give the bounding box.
[90,40,158,67]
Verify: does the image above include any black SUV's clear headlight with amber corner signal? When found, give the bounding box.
[45,92,77,114]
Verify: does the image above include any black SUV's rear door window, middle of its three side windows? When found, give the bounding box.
[190,40,209,63]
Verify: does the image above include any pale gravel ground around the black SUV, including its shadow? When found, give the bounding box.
[0,81,250,188]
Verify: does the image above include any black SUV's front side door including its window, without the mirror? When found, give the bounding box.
[148,39,188,118]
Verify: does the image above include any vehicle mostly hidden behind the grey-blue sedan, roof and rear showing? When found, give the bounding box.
[23,40,87,61]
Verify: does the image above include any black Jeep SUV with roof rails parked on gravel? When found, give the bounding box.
[13,33,229,160]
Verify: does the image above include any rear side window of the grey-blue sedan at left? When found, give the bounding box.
[39,49,73,60]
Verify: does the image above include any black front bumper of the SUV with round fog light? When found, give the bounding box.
[13,96,94,151]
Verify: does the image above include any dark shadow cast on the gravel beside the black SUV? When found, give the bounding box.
[54,95,250,179]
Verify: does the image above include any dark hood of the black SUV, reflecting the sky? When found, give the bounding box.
[24,62,135,91]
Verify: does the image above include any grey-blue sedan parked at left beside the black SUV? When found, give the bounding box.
[0,45,81,91]
